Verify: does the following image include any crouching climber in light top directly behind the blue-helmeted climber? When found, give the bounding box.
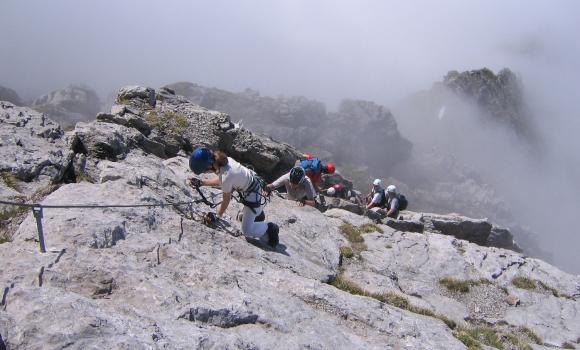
[266,166,316,207]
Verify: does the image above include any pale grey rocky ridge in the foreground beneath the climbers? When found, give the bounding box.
[0,87,580,349]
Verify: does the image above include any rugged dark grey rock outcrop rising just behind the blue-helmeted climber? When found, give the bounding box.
[78,86,299,180]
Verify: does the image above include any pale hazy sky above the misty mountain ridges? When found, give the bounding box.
[0,0,580,106]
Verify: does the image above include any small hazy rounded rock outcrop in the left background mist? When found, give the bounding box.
[31,85,101,129]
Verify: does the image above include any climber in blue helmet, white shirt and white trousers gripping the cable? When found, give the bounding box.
[189,147,279,247]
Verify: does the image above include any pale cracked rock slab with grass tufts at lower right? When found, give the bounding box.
[336,211,580,346]
